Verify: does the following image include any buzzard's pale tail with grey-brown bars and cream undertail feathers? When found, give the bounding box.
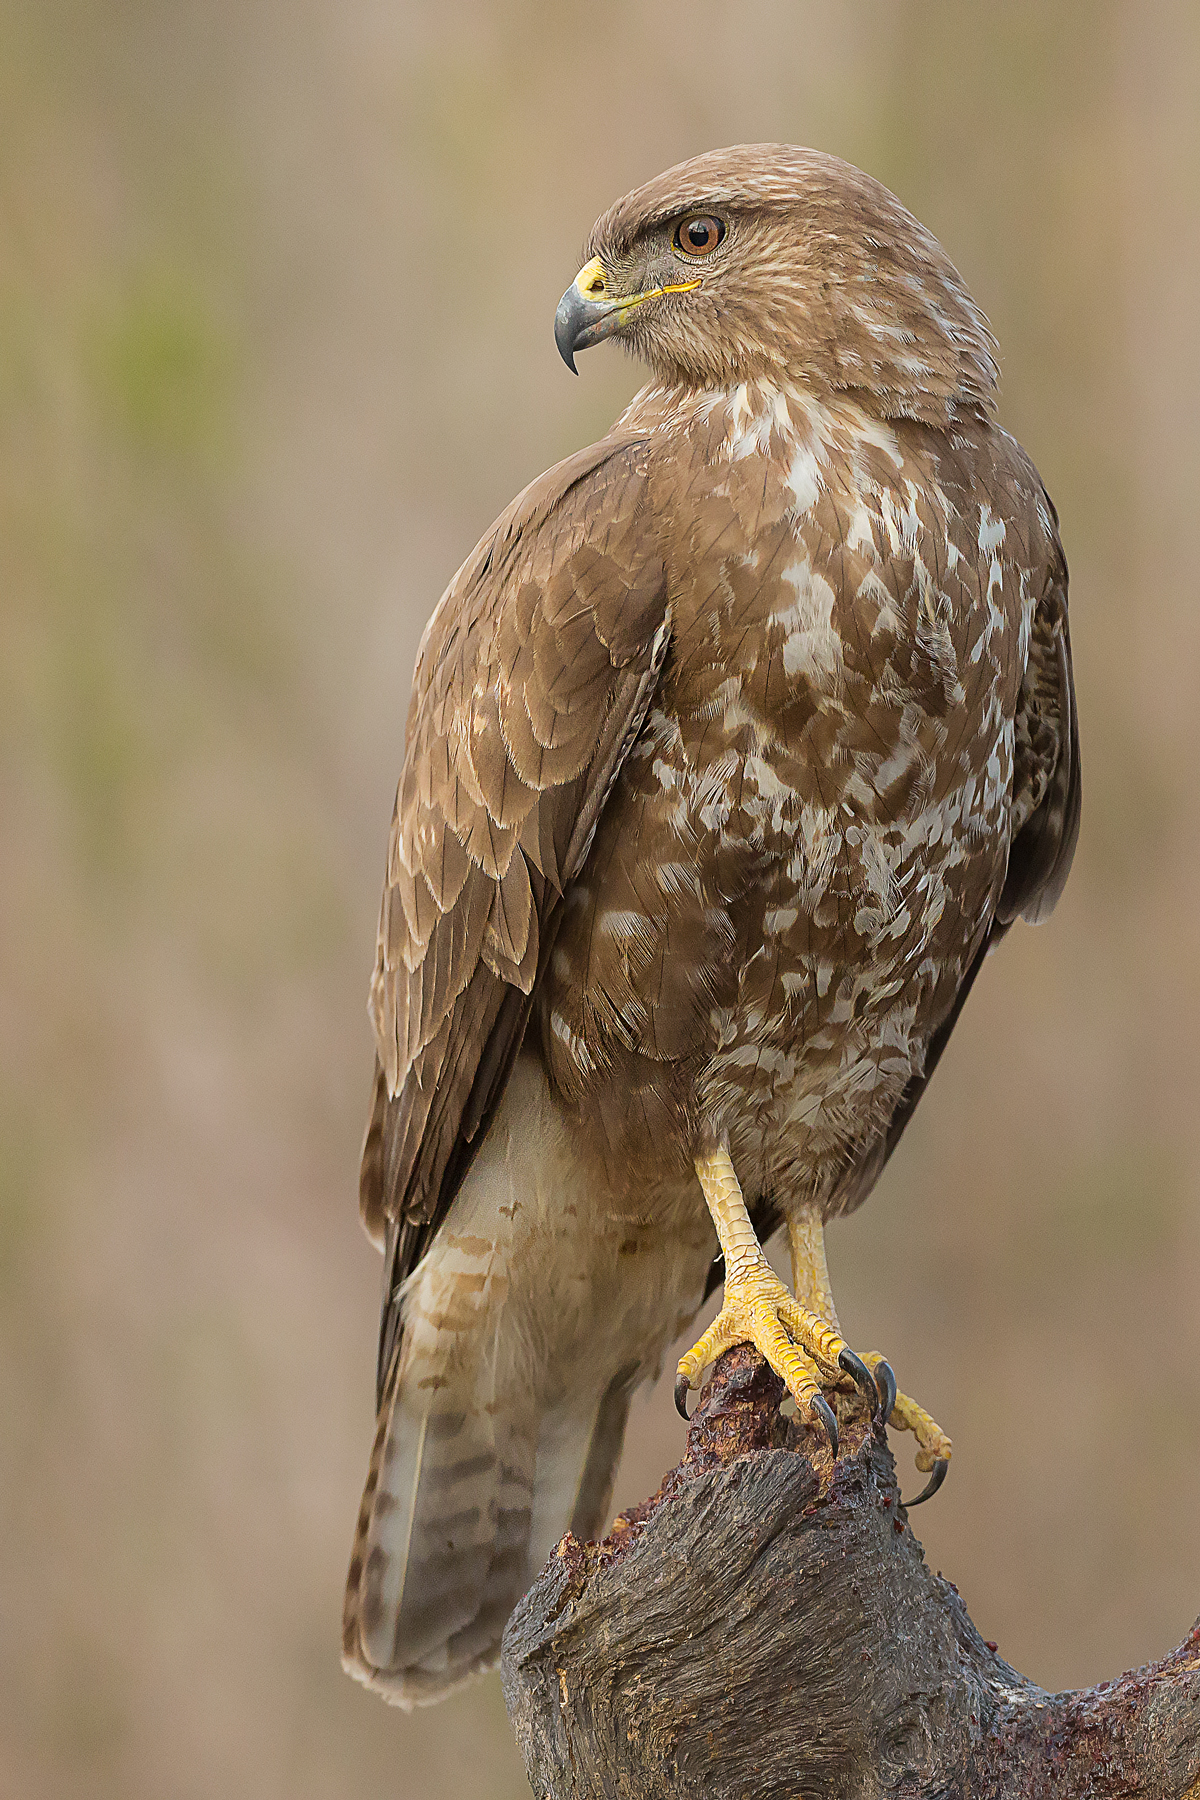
[342,1057,712,1706]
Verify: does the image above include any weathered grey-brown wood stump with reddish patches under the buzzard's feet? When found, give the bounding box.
[502,1346,1200,1800]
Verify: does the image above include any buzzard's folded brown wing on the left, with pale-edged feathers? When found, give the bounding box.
[360,437,669,1404]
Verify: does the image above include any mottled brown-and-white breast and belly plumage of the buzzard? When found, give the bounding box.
[536,385,1067,1210]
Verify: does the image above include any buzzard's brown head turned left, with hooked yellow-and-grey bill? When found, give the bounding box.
[554,144,997,425]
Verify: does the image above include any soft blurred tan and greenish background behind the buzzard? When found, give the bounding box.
[0,0,1200,1800]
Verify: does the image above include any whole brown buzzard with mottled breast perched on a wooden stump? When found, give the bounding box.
[344,144,1079,1705]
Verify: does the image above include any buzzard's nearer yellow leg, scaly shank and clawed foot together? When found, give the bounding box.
[675,1145,878,1456]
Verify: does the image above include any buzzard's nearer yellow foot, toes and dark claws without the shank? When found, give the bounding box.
[675,1251,881,1467]
